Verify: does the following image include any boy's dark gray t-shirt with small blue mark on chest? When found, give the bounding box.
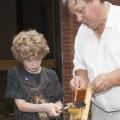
[5,65,64,120]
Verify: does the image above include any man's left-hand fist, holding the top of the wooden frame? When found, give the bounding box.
[70,76,88,91]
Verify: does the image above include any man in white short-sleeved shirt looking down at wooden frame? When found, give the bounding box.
[64,0,120,120]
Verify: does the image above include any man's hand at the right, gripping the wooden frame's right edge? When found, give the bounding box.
[91,73,115,92]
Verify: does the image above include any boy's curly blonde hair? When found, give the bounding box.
[11,30,49,61]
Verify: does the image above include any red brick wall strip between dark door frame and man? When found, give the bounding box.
[61,3,78,120]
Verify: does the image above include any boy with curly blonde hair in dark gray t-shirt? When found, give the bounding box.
[6,30,63,120]
